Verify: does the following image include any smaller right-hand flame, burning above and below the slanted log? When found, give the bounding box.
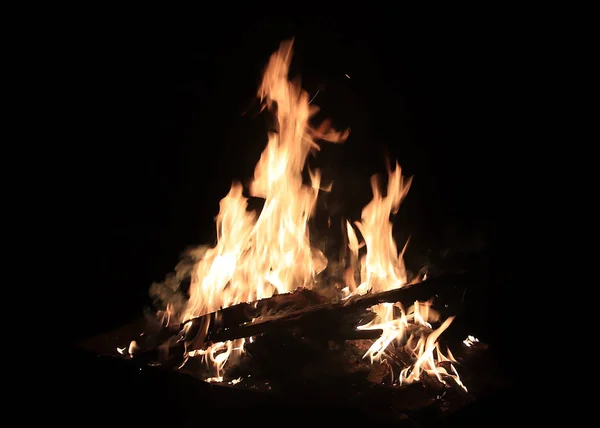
[345,168,466,390]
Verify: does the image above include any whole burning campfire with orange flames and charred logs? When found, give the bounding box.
[85,41,506,424]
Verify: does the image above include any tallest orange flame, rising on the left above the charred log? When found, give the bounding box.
[182,41,347,319]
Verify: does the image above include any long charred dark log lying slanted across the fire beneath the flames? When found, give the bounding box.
[131,274,472,362]
